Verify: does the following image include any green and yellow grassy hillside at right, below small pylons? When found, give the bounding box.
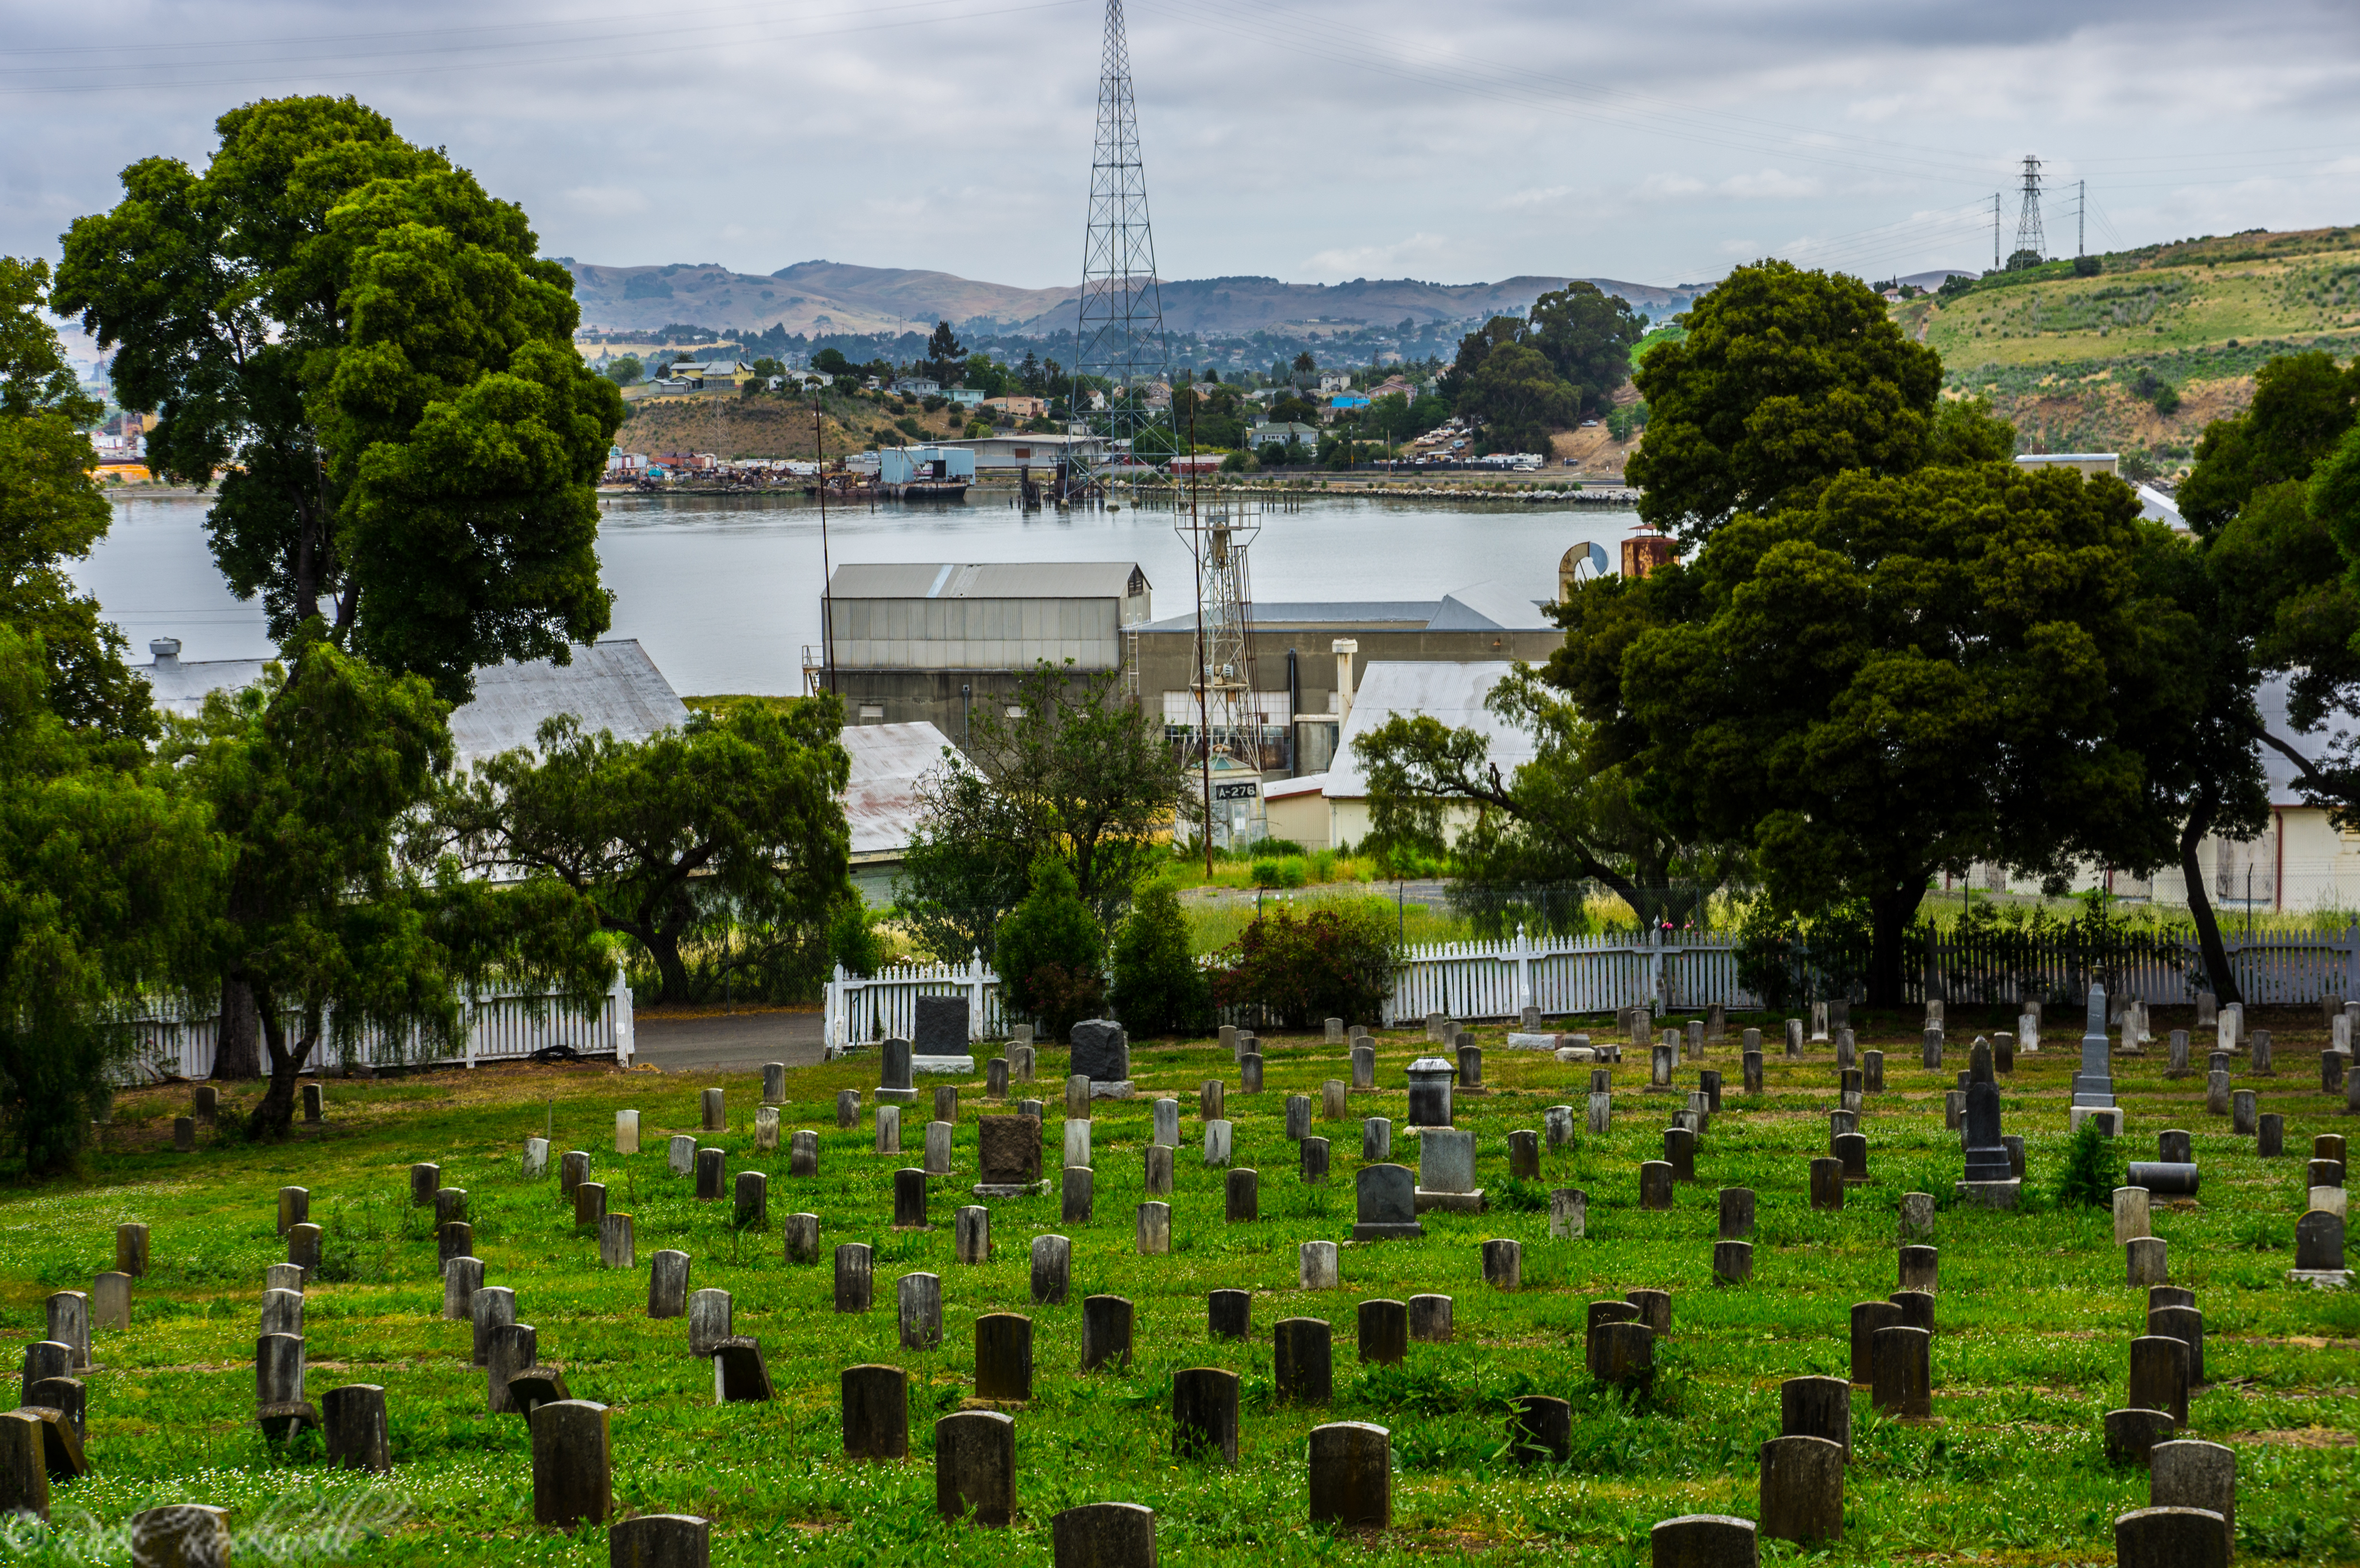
[1893,227,2360,467]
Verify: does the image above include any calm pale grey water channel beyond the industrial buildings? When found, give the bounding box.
[75,493,1638,694]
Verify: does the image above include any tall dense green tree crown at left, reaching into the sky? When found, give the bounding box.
[54,97,623,701]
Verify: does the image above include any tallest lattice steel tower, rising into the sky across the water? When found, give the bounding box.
[1074,0,1170,463]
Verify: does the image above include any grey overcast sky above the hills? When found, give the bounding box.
[0,0,2360,288]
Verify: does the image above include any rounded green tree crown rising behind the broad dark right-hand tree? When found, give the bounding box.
[1623,262,1942,541]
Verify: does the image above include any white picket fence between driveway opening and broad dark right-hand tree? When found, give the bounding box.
[826,928,1758,1049]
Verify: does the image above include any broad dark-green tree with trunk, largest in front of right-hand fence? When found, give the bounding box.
[1565,463,2202,1004]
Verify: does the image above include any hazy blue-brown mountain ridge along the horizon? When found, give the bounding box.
[557,257,1702,335]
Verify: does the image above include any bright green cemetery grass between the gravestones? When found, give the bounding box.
[18,1008,2360,1568]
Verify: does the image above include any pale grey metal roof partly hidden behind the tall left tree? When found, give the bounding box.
[132,637,689,768]
